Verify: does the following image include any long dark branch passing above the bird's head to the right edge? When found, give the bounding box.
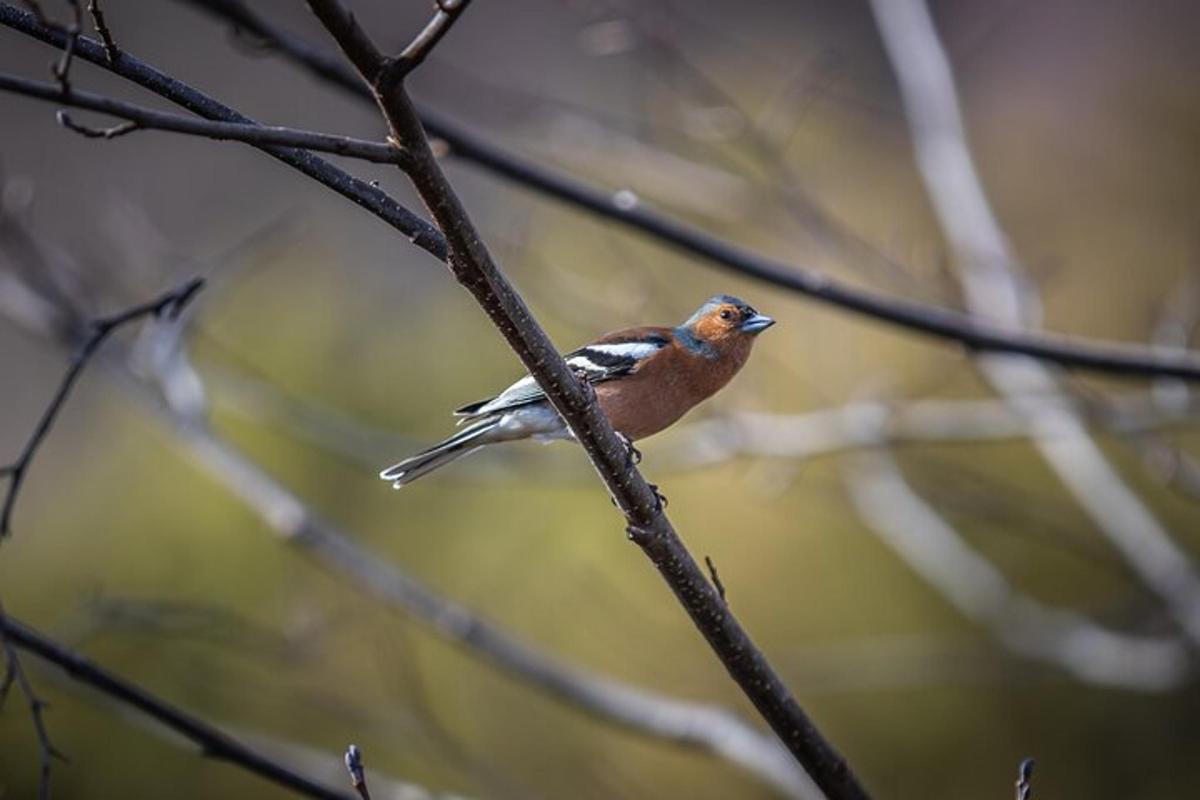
[166,0,1200,380]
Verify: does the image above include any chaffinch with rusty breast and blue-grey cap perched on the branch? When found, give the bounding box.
[379,295,775,489]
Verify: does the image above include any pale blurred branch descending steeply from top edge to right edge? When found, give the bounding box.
[871,0,1200,648]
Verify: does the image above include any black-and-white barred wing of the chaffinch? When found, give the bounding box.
[455,327,671,419]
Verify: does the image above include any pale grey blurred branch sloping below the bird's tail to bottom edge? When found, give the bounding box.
[0,247,814,798]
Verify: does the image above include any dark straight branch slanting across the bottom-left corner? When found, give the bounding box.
[0,616,352,800]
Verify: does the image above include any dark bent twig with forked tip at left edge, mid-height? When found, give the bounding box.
[0,278,204,537]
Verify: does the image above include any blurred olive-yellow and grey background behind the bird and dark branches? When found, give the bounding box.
[0,0,1200,799]
